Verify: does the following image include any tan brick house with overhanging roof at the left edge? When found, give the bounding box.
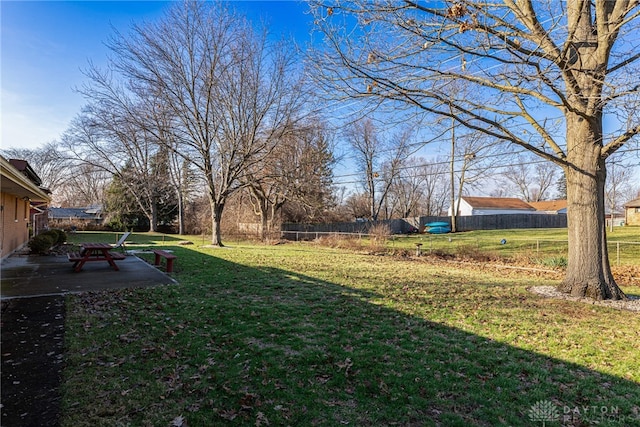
[0,156,51,259]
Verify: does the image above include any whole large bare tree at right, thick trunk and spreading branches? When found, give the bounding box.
[312,0,640,299]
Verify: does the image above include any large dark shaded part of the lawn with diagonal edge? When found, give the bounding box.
[63,248,640,426]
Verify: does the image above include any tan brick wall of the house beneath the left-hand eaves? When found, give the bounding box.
[0,193,30,258]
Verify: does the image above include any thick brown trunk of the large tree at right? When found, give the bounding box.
[558,115,626,300]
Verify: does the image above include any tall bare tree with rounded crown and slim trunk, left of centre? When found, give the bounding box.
[109,1,304,246]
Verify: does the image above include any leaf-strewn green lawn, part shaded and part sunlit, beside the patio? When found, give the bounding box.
[62,233,640,427]
